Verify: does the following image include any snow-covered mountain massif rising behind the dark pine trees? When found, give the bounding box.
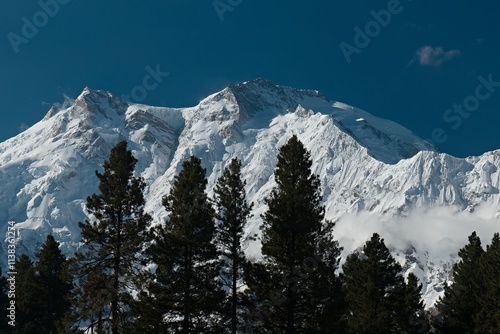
[0,79,500,306]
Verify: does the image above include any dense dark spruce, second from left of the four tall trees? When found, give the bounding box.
[144,156,224,334]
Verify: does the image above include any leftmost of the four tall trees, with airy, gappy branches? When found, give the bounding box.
[72,141,151,334]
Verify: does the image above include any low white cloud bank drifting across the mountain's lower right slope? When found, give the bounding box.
[334,207,500,262]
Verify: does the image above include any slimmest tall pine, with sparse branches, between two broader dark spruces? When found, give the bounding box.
[214,159,253,334]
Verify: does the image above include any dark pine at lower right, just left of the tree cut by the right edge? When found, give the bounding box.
[435,232,484,334]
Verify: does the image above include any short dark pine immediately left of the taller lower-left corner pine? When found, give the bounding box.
[15,254,43,334]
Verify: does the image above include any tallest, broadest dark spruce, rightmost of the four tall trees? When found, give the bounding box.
[247,135,342,334]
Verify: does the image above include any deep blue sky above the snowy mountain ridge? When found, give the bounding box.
[0,0,500,157]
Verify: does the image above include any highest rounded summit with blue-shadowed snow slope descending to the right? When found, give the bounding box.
[187,78,435,164]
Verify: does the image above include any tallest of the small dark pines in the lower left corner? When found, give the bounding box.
[35,234,72,333]
